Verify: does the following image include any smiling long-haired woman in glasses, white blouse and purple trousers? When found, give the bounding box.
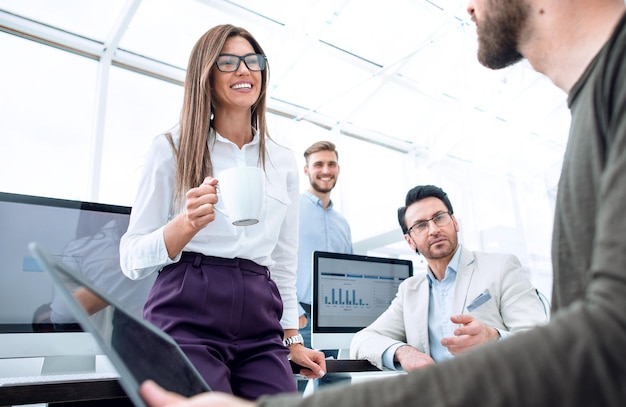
[120,25,325,399]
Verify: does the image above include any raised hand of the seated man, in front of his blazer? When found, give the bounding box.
[441,315,500,355]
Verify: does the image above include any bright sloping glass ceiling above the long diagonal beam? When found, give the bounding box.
[0,0,569,165]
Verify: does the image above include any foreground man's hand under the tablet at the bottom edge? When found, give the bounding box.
[139,380,254,407]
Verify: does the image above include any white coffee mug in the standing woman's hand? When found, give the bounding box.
[215,167,265,226]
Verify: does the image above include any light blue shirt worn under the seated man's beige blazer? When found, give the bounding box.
[383,245,461,369]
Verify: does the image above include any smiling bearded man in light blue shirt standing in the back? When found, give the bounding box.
[296,141,353,347]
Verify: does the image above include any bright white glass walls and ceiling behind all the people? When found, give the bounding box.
[0,0,569,300]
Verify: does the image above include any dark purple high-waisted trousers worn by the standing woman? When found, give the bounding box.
[144,252,297,400]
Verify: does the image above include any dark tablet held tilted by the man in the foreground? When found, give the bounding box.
[29,242,210,407]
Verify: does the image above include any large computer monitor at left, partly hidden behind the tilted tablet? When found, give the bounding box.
[0,192,154,374]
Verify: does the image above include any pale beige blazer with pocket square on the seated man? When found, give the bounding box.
[350,246,547,368]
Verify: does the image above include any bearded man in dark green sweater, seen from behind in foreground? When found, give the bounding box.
[142,0,626,407]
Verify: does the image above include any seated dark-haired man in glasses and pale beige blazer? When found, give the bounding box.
[350,185,547,371]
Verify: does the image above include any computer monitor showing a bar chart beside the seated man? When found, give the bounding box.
[311,251,413,358]
